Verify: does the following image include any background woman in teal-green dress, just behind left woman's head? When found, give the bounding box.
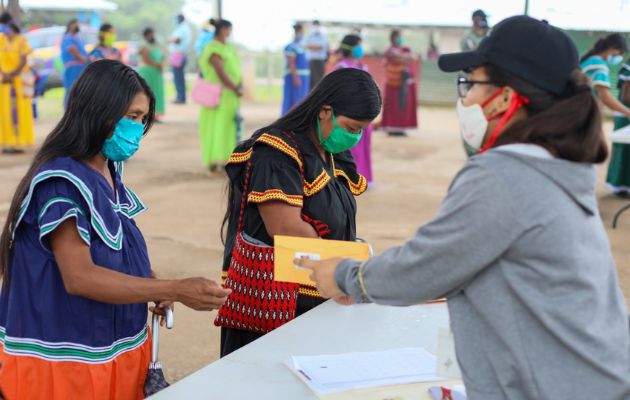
[138,28,165,122]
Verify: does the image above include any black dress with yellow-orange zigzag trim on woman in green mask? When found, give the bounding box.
[221,130,367,356]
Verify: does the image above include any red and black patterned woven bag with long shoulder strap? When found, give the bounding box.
[214,133,315,333]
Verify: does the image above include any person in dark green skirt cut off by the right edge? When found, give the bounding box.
[606,59,630,196]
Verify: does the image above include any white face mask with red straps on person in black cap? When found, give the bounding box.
[457,89,529,157]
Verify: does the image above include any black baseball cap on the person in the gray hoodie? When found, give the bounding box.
[438,15,579,95]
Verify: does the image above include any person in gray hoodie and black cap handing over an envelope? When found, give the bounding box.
[296,16,630,400]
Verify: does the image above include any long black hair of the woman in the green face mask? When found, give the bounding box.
[221,68,383,244]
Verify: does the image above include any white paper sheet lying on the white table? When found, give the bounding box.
[287,347,444,393]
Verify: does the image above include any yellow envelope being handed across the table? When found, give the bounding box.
[274,236,370,286]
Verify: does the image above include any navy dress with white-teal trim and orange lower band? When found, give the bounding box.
[0,158,151,399]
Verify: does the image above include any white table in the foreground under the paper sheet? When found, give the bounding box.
[151,301,461,400]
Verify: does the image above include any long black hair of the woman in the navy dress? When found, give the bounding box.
[0,60,155,283]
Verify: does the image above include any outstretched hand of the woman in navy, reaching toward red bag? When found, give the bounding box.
[175,278,232,311]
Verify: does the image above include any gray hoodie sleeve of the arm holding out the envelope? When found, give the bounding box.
[335,159,524,306]
